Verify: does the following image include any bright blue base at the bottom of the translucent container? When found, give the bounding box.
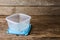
[6,24,31,36]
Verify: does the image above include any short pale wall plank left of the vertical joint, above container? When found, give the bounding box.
[0,7,15,15]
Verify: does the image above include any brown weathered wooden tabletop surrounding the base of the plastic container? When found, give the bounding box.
[0,15,60,40]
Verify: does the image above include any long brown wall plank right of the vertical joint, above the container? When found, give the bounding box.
[16,7,60,15]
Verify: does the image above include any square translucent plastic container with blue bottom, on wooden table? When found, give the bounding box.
[6,14,31,35]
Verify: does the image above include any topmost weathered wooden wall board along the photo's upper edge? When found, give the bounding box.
[0,0,60,6]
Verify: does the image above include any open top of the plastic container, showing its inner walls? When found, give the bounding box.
[7,14,31,23]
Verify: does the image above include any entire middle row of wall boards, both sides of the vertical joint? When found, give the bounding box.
[0,7,60,15]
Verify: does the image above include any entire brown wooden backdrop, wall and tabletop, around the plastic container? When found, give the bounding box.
[0,0,60,40]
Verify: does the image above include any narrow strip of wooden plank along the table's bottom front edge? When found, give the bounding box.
[0,37,60,40]
